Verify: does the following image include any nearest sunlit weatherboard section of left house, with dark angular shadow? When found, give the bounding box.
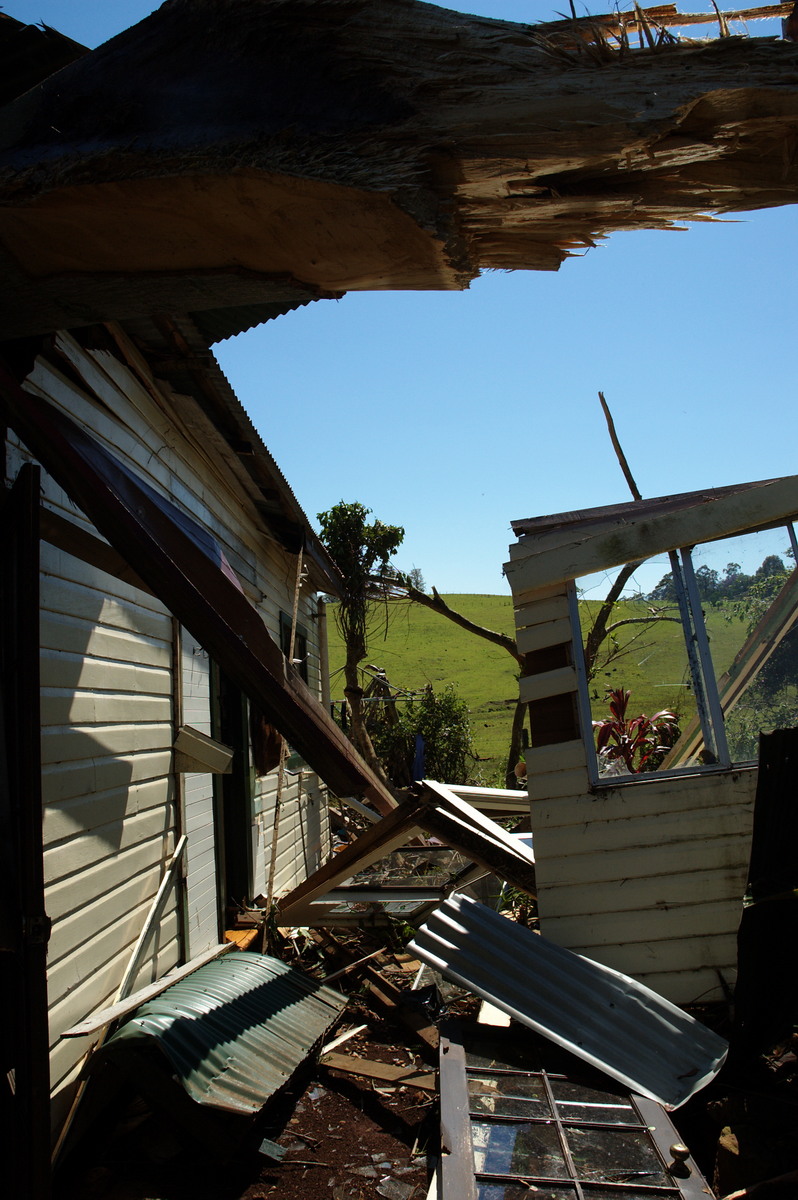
[41,545,180,1115]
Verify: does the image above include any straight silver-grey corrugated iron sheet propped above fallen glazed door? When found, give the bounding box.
[408,895,726,1109]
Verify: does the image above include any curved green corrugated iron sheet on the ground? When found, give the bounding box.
[103,952,347,1112]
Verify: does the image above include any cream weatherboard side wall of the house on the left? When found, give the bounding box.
[6,335,329,1127]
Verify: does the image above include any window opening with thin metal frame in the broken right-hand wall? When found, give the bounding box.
[580,527,798,779]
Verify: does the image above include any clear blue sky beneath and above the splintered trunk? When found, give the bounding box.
[4,0,798,593]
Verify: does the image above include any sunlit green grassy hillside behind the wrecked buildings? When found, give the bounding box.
[329,595,744,785]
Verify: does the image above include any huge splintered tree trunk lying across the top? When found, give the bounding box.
[0,0,798,336]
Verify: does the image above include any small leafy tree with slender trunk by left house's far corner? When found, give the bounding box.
[318,500,404,779]
